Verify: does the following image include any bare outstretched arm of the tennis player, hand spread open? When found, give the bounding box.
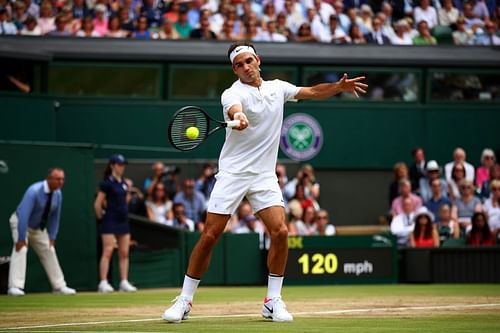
[295,74,368,99]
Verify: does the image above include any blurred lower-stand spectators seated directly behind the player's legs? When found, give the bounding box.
[127,162,336,246]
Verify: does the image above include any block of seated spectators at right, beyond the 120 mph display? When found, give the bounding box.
[389,148,500,247]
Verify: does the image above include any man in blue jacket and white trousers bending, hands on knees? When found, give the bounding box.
[7,168,76,296]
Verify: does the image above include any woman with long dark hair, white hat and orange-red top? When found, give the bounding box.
[410,207,439,247]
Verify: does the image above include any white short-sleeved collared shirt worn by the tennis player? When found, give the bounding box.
[219,80,300,174]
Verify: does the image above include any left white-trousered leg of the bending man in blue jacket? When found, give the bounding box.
[7,213,29,296]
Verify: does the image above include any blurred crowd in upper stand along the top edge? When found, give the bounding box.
[0,0,500,45]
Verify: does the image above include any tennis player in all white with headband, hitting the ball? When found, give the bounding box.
[163,42,368,323]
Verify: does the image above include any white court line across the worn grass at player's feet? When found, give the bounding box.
[0,303,500,333]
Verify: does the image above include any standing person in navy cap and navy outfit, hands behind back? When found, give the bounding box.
[94,155,137,293]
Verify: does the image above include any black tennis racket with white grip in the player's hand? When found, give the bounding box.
[168,106,240,151]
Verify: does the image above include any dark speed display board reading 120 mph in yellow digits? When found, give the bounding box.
[285,235,398,284]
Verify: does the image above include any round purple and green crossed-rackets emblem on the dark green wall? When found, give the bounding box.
[280,113,323,161]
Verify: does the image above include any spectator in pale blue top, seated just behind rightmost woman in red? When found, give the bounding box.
[452,179,483,231]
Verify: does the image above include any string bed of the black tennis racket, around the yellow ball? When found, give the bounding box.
[170,109,209,150]
